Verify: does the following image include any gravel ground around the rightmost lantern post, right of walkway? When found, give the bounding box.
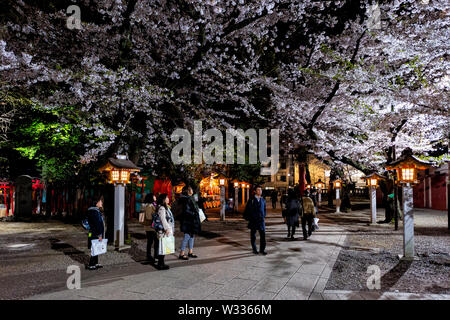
[326,209,450,294]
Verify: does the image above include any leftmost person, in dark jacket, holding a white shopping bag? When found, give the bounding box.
[87,197,105,270]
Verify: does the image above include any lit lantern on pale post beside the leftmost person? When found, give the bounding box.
[99,155,141,250]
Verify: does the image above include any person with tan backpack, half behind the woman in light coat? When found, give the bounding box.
[141,193,159,263]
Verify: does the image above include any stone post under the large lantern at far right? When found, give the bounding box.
[403,183,414,260]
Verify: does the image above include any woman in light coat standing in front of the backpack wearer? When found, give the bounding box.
[153,193,175,270]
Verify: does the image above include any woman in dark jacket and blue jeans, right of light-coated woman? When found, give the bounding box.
[177,185,201,260]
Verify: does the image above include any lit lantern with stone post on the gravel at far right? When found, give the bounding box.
[386,148,431,260]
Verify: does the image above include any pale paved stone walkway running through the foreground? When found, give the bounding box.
[27,214,345,300]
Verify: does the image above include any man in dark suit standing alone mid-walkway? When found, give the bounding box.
[244,186,267,255]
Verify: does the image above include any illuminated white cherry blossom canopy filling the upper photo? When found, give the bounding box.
[0,0,450,179]
